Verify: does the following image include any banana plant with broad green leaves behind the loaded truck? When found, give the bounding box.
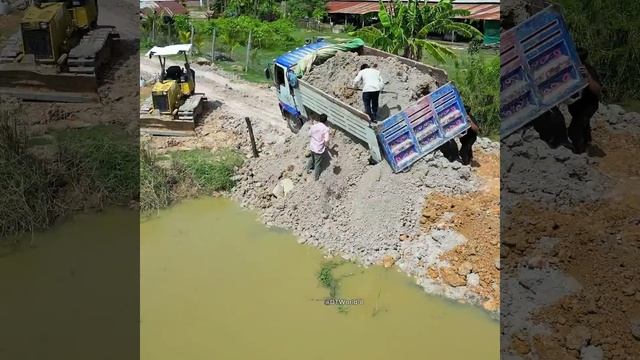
[359,0,482,62]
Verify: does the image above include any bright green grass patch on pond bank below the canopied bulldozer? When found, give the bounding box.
[140,144,244,215]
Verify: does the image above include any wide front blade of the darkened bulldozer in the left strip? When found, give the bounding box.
[0,68,100,103]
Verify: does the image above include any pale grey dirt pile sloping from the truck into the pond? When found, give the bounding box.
[233,117,497,302]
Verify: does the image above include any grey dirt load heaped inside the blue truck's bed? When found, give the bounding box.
[303,52,437,119]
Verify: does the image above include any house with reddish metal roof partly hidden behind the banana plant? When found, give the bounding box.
[327,0,500,44]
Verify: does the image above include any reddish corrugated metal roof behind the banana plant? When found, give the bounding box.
[327,0,500,20]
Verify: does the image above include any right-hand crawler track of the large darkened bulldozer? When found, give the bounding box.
[67,27,120,76]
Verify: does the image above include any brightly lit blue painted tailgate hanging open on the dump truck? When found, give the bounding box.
[378,83,470,172]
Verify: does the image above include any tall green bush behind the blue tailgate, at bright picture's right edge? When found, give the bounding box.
[452,53,500,138]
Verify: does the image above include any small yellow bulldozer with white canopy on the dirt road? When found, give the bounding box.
[140,44,207,136]
